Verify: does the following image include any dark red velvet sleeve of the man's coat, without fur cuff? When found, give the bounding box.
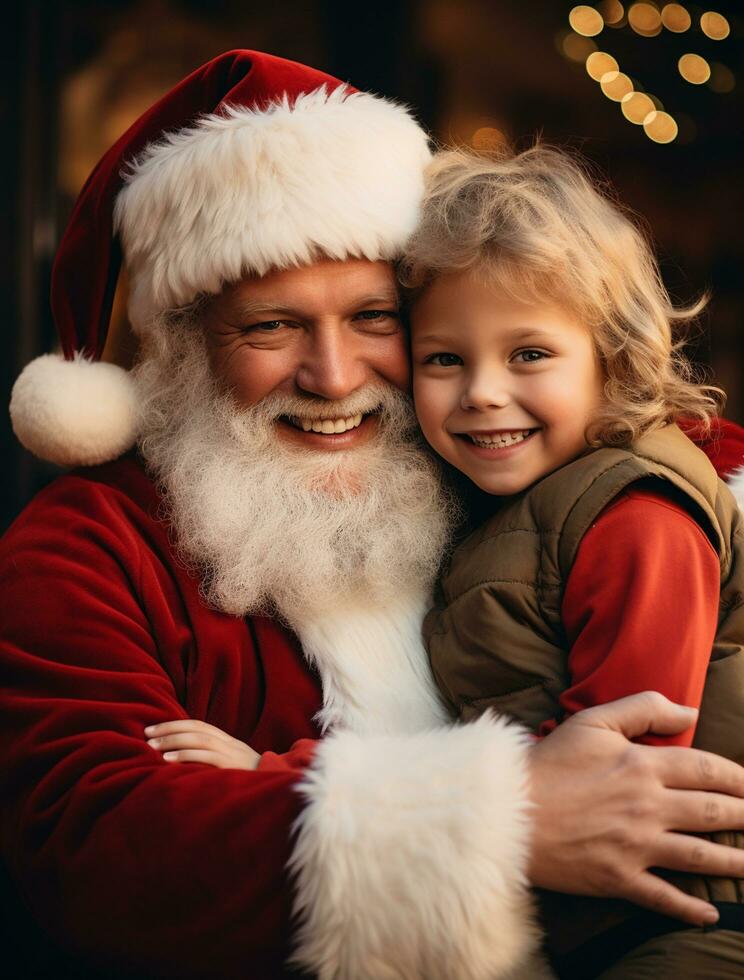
[0,470,316,980]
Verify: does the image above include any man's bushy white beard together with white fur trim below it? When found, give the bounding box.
[135,316,456,731]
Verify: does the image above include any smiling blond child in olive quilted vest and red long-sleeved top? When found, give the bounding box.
[401,147,744,980]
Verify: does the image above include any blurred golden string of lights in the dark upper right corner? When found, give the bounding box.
[560,0,736,143]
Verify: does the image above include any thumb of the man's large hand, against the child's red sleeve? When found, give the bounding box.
[572,691,697,738]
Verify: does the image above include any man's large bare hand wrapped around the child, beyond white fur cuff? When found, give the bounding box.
[529,691,744,925]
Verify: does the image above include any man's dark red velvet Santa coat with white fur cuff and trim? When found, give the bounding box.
[0,457,533,980]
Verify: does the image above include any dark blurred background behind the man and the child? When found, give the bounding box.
[0,0,744,529]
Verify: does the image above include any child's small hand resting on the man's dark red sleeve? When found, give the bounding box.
[145,718,261,769]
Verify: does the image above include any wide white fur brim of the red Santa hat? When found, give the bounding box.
[114,87,431,329]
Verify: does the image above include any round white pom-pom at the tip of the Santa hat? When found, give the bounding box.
[10,354,138,466]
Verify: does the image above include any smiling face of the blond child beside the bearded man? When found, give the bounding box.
[412,273,602,495]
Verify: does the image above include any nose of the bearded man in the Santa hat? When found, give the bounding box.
[295,325,372,400]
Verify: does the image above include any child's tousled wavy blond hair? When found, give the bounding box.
[399,145,724,445]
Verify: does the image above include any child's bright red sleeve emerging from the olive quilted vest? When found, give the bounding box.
[540,490,720,745]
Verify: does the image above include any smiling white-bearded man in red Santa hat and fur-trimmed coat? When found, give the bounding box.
[0,52,744,980]
